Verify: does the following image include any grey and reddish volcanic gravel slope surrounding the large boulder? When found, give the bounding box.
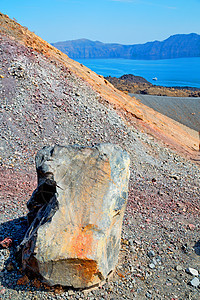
[0,36,200,300]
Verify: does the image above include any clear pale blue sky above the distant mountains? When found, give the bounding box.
[0,0,200,44]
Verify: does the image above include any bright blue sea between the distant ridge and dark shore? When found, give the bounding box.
[78,57,200,88]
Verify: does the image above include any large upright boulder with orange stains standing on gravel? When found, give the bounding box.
[22,144,129,288]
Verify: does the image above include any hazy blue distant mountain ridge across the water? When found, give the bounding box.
[51,33,200,59]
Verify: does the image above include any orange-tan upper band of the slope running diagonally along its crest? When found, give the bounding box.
[0,12,198,155]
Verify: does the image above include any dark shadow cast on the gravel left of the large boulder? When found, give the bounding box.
[0,217,84,299]
